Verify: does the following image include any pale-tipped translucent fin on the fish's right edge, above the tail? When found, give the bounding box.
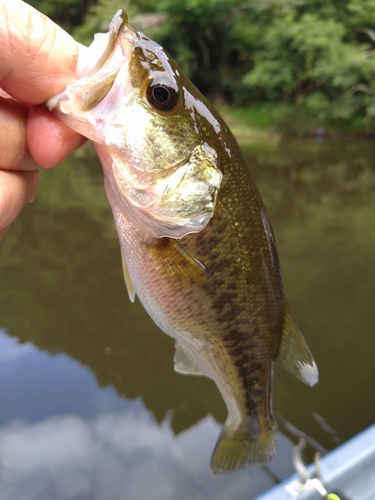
[276,300,318,385]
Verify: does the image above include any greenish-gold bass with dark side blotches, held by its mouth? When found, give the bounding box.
[46,10,318,475]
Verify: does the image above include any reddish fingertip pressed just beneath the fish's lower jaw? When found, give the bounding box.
[26,106,87,168]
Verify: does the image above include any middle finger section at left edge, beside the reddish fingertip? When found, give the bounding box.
[0,98,38,170]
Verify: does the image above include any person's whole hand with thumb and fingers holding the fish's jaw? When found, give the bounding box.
[0,0,85,241]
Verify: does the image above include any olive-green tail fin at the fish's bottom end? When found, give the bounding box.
[211,426,276,475]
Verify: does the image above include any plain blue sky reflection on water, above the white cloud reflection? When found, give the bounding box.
[0,329,130,426]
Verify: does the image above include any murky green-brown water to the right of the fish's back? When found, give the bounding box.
[246,139,375,449]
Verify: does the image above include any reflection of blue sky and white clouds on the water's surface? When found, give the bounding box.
[0,333,292,500]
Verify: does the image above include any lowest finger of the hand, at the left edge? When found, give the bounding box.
[0,170,39,230]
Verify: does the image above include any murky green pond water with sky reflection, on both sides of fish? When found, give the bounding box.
[0,138,375,500]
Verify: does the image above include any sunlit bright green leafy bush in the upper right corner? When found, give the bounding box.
[239,0,375,119]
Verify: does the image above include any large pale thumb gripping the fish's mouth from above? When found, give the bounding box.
[0,0,84,104]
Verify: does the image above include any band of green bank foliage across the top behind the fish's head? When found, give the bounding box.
[30,0,375,131]
